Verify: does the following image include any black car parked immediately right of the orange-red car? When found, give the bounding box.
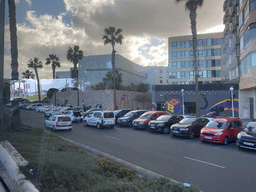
[148,115,183,134]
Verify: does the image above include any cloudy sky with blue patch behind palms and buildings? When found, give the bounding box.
[5,0,224,79]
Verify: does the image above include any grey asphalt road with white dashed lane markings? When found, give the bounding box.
[21,110,256,192]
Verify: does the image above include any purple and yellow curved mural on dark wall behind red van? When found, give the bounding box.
[201,98,239,116]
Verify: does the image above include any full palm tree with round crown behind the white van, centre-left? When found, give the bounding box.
[102,27,123,110]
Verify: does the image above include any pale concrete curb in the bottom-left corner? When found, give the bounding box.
[0,141,39,192]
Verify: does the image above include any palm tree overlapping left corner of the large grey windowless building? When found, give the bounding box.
[67,45,84,106]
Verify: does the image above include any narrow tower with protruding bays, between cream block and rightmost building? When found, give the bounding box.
[222,0,240,83]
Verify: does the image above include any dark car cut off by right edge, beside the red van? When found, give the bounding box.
[236,121,256,150]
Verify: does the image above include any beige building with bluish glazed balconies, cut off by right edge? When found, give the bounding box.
[238,0,256,118]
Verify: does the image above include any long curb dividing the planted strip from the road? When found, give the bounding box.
[60,136,180,185]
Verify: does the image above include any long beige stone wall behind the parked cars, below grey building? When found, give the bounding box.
[50,90,152,110]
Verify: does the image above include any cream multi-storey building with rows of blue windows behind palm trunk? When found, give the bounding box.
[168,32,223,85]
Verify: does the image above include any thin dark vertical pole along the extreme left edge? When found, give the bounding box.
[0,0,5,124]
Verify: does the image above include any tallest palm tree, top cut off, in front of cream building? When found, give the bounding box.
[175,0,204,117]
